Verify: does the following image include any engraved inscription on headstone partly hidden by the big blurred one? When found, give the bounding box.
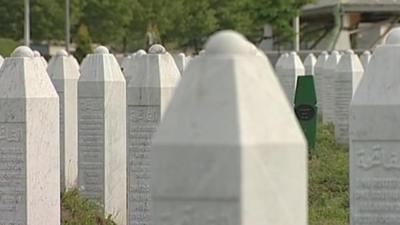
[128,106,160,225]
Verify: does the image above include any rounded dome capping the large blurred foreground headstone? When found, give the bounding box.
[205,30,252,54]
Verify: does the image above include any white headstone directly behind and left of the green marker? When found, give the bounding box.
[278,52,306,104]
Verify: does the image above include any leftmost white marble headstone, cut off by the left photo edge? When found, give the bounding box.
[0,47,60,225]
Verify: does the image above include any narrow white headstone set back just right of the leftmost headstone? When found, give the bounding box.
[47,50,80,191]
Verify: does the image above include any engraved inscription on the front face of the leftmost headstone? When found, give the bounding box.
[0,123,26,225]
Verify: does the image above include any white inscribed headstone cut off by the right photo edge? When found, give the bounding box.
[350,28,400,225]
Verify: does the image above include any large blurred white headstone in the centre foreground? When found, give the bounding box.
[152,31,307,225]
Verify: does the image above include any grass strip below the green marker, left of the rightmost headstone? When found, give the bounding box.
[309,125,349,225]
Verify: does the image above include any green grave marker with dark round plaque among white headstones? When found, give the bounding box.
[294,75,318,150]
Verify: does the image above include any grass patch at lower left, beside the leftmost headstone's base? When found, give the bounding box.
[61,190,116,225]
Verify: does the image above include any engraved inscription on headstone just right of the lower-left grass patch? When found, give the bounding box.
[78,98,104,204]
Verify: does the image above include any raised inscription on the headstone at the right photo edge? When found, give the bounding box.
[351,141,400,225]
